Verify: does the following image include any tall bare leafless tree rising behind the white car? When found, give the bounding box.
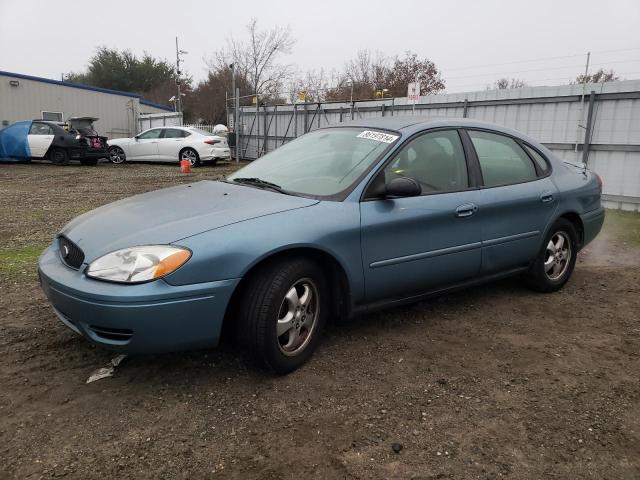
[208,18,295,97]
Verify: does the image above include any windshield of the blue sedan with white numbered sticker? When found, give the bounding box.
[227,127,400,197]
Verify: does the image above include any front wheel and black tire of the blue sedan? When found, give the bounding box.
[236,258,329,374]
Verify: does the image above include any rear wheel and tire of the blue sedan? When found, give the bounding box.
[527,218,578,293]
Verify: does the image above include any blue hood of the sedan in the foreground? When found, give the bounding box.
[60,181,318,263]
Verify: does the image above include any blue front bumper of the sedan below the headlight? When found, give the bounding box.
[38,246,239,354]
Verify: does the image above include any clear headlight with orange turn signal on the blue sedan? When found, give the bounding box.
[86,245,191,283]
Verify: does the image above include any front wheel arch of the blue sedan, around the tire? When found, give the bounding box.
[222,246,352,342]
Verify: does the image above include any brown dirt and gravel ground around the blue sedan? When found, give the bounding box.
[0,164,640,479]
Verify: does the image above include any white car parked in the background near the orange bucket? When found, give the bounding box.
[107,125,231,167]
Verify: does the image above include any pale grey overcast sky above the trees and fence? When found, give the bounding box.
[0,0,640,92]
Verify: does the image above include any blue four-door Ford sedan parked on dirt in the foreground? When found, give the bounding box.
[39,117,604,373]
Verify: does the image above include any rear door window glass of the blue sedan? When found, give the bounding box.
[468,130,537,187]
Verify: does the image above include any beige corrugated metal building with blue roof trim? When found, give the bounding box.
[0,71,173,138]
